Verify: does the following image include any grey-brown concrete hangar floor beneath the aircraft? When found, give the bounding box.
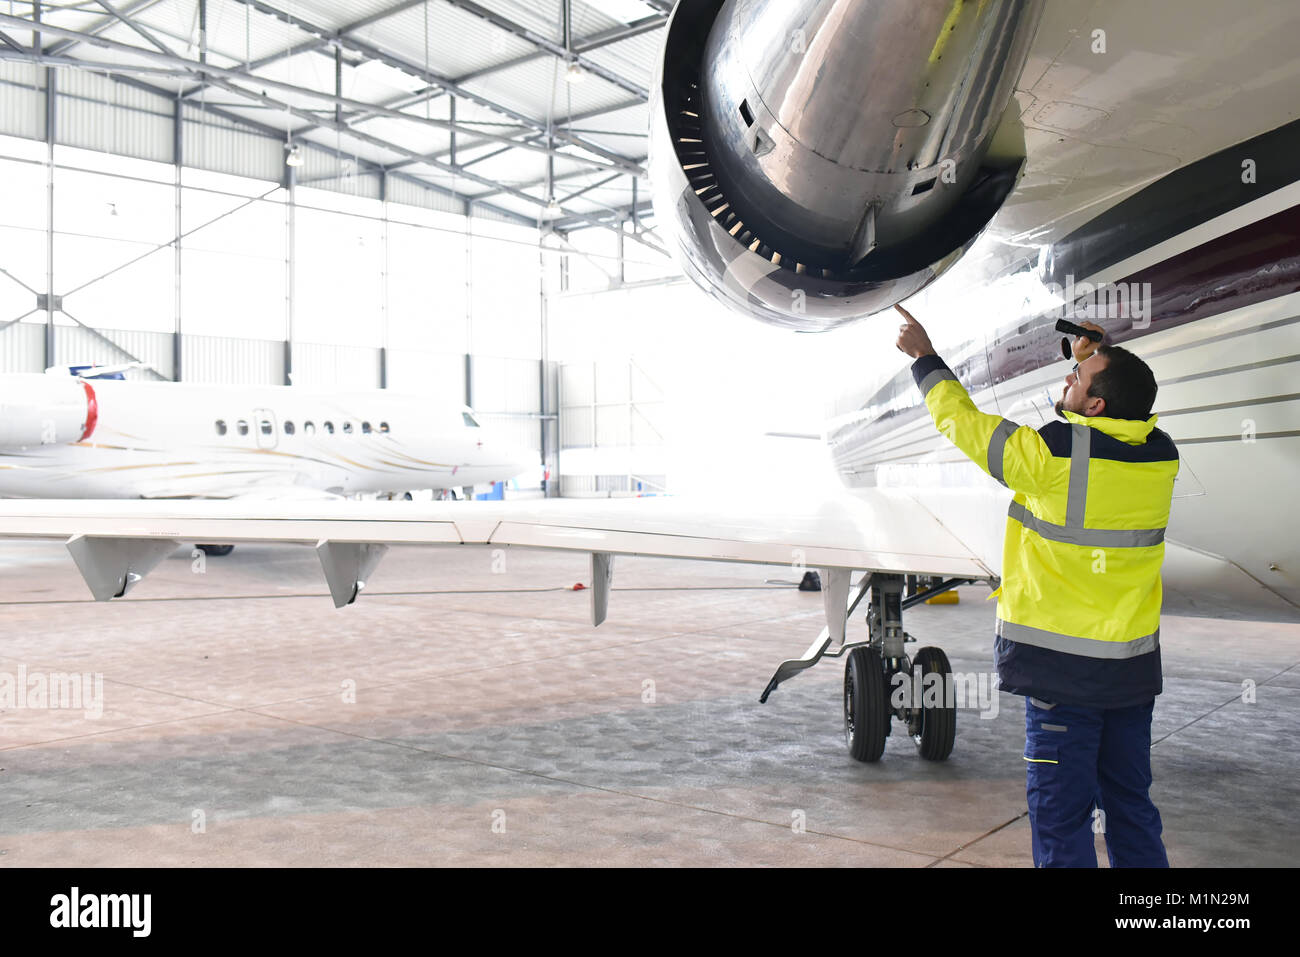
[0,542,1300,867]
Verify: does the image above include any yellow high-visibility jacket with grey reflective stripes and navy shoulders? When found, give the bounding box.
[913,356,1178,707]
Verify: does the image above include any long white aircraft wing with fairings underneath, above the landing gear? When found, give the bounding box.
[0,489,993,608]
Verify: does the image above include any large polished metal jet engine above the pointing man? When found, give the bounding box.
[650,0,1043,330]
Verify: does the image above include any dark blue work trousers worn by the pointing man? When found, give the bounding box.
[1024,698,1169,867]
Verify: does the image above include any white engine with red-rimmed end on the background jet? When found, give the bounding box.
[0,373,99,449]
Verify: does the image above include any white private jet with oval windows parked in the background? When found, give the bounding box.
[0,369,536,501]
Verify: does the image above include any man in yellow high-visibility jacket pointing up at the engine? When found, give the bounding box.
[897,306,1178,867]
